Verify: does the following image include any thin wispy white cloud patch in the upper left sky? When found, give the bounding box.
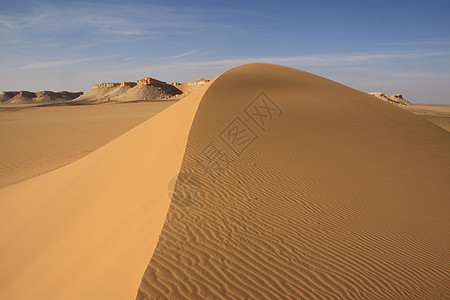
[0,3,207,36]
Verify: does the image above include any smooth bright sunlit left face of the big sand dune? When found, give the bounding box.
[0,86,211,299]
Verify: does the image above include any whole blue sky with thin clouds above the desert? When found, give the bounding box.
[0,0,450,104]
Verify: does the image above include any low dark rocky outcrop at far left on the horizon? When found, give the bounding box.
[0,91,83,104]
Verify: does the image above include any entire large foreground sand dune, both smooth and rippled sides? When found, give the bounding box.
[0,64,450,299]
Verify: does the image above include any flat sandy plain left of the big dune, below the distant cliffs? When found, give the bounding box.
[0,101,175,187]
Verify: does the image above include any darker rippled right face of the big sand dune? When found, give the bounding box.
[138,64,450,299]
